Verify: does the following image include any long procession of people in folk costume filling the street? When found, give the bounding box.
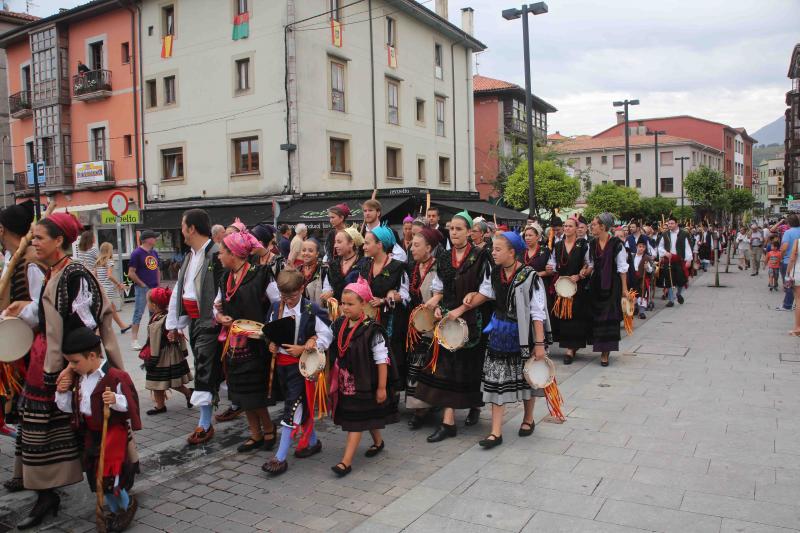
[0,199,726,531]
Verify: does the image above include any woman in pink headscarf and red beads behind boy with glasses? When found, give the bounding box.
[214,232,276,453]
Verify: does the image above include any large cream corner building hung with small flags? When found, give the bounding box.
[142,0,484,212]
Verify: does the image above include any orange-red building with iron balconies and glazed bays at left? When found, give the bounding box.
[0,0,143,253]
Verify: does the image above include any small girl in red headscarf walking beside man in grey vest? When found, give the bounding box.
[139,287,193,416]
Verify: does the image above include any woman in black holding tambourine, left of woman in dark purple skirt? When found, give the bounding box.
[546,217,592,365]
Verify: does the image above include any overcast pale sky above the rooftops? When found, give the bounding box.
[9,0,800,135]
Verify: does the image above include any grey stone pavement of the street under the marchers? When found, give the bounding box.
[0,262,800,533]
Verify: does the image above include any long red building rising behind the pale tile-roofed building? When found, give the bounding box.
[594,113,757,189]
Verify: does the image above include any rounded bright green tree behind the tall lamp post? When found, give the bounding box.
[504,159,581,216]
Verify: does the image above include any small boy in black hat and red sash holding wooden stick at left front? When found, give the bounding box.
[55,327,142,531]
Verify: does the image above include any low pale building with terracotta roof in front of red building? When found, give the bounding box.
[553,135,724,200]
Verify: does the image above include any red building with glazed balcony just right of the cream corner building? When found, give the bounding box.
[472,75,557,198]
